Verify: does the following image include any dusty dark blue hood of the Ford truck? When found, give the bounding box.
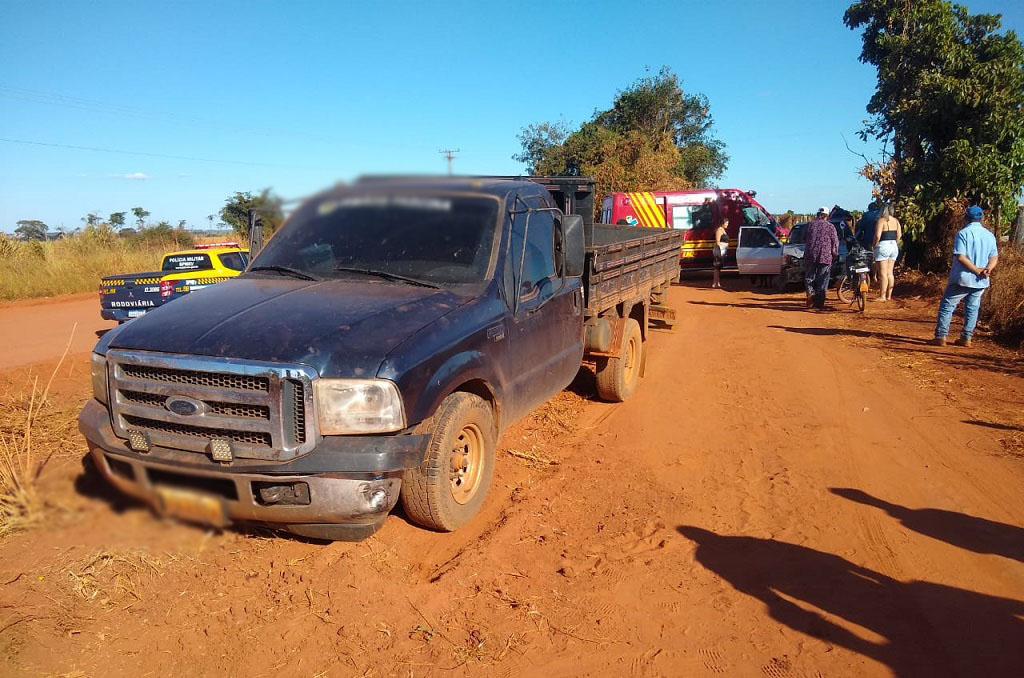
[107,277,471,377]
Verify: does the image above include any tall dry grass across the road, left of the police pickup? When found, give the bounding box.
[0,232,180,300]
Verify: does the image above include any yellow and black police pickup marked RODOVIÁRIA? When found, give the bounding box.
[99,243,249,323]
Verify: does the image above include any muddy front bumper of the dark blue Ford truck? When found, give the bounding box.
[79,399,429,539]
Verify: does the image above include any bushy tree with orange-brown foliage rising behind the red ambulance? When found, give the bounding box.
[512,68,728,209]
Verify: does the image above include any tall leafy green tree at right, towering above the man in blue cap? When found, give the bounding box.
[844,0,1024,268]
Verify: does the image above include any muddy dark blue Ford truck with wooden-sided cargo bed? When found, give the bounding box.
[79,177,681,539]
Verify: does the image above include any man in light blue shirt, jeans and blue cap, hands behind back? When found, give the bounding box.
[932,206,999,346]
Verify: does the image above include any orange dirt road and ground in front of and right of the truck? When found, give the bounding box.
[0,287,1024,678]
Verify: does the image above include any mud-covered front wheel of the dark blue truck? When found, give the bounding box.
[401,393,497,532]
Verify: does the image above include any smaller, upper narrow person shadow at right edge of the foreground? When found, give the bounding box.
[828,488,1024,561]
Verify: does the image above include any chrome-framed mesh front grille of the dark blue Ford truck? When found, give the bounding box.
[106,350,316,461]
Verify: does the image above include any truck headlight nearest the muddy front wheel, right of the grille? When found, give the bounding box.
[313,379,406,435]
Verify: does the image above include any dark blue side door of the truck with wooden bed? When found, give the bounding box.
[505,197,583,418]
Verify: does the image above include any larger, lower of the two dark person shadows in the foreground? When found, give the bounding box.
[677,525,1024,677]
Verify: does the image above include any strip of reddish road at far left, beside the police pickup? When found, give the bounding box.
[0,294,116,369]
